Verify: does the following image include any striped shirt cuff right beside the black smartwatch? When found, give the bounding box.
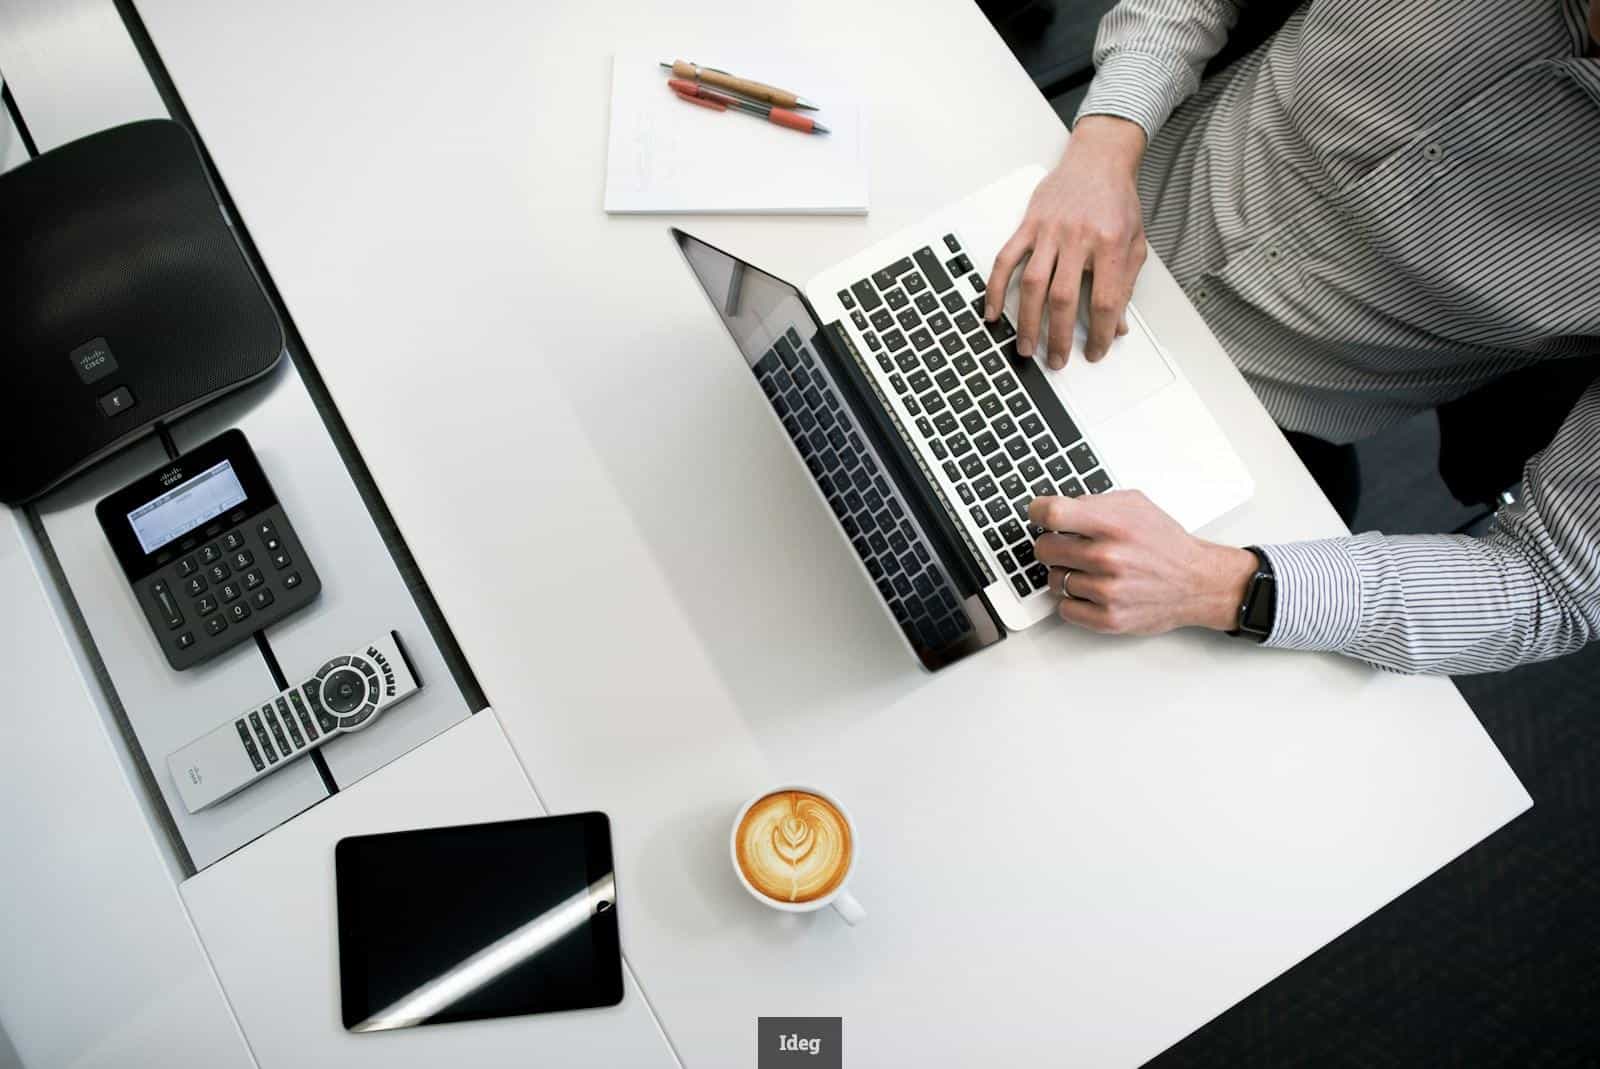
[1259,538,1362,651]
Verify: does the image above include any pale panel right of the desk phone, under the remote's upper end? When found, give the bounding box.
[173,358,469,790]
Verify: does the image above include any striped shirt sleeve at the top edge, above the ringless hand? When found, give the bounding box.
[1078,0,1243,138]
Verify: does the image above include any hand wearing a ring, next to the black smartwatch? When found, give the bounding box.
[1027,490,1258,635]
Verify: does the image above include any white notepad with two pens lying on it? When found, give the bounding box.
[605,53,867,214]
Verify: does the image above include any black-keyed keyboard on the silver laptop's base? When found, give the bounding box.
[838,234,1114,597]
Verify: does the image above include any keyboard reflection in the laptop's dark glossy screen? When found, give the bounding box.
[755,326,971,650]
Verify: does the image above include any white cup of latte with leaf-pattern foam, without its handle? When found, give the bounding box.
[734,791,851,903]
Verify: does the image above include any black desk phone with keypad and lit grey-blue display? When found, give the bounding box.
[94,429,322,671]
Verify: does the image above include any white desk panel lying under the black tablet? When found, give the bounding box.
[182,711,678,1069]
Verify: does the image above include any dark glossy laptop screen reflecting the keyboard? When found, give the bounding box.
[674,230,1003,669]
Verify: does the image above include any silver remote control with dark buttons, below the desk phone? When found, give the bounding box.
[166,631,422,813]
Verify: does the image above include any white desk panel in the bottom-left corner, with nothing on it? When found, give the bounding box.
[0,509,254,1069]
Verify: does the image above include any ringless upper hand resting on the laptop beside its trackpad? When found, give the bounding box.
[984,115,1146,370]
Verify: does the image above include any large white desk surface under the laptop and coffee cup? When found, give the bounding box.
[139,0,1530,1067]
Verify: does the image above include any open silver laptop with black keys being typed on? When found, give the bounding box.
[672,168,1253,671]
